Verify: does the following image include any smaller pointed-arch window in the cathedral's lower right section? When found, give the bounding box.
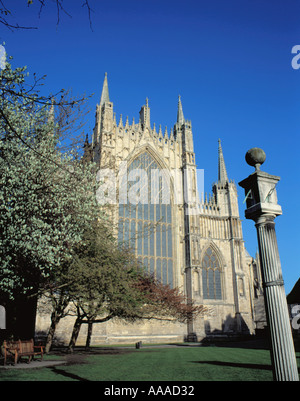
[202,247,222,299]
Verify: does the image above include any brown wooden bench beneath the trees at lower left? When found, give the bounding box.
[3,339,44,365]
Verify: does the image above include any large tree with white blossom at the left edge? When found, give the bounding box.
[0,63,99,336]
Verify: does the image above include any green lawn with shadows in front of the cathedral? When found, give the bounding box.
[0,347,300,381]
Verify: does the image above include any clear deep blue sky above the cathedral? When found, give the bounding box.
[0,0,300,293]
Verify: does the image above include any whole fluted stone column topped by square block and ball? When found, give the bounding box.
[239,148,299,381]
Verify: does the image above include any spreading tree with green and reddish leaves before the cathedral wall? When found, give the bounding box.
[59,222,206,351]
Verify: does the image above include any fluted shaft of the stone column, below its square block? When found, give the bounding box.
[255,215,299,381]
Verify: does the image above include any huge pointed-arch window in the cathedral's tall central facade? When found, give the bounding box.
[119,152,174,286]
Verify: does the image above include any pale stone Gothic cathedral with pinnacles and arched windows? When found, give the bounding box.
[37,74,264,344]
